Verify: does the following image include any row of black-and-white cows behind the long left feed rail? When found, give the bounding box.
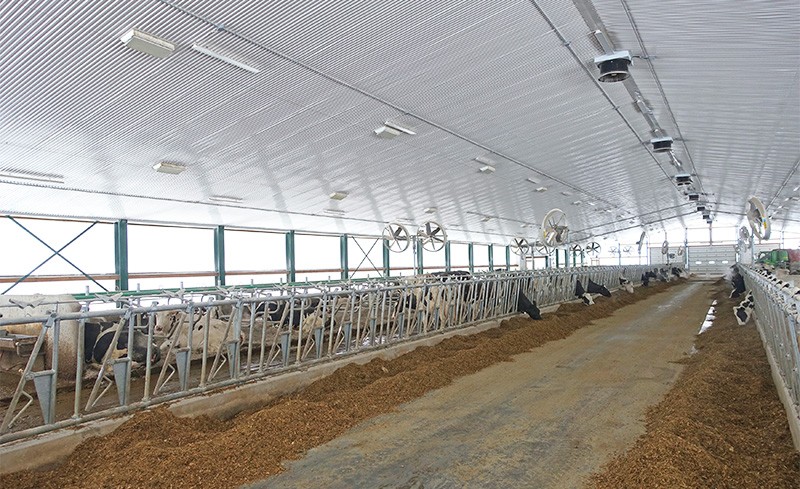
[0,271,648,384]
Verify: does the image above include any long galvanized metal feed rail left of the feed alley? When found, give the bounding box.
[0,266,650,443]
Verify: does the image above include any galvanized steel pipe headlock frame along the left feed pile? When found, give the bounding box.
[0,266,648,443]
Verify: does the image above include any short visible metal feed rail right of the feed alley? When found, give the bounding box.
[739,264,800,417]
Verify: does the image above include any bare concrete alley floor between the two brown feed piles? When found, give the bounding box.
[245,282,711,489]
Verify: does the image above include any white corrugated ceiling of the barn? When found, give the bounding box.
[0,0,800,243]
